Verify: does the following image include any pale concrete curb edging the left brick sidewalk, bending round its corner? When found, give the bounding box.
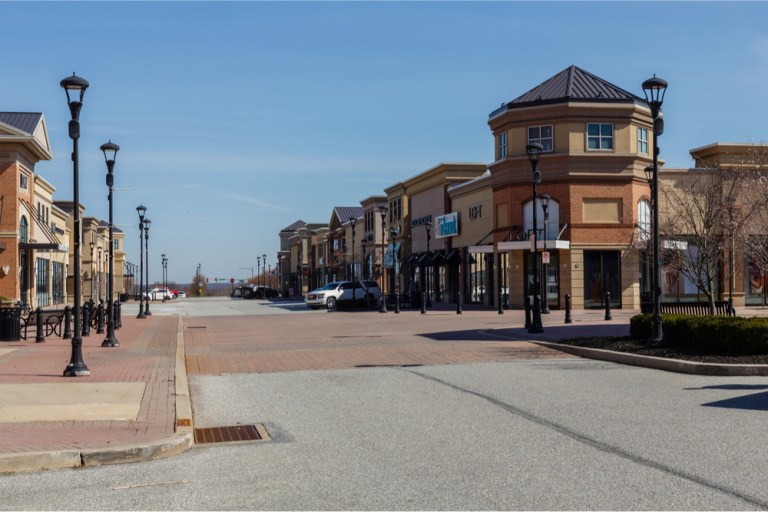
[0,316,195,474]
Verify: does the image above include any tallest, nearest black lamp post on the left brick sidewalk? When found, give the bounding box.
[60,73,91,377]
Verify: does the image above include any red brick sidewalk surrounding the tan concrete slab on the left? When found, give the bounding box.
[0,315,179,455]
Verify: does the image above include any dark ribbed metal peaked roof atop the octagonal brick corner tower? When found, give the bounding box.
[489,66,646,117]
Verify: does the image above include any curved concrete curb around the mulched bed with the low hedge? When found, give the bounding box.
[531,340,768,377]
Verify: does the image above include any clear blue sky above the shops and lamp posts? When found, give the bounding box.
[0,1,768,283]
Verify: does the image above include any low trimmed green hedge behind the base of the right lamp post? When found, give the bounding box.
[629,315,768,355]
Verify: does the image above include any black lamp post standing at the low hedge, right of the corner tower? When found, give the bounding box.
[643,75,667,344]
